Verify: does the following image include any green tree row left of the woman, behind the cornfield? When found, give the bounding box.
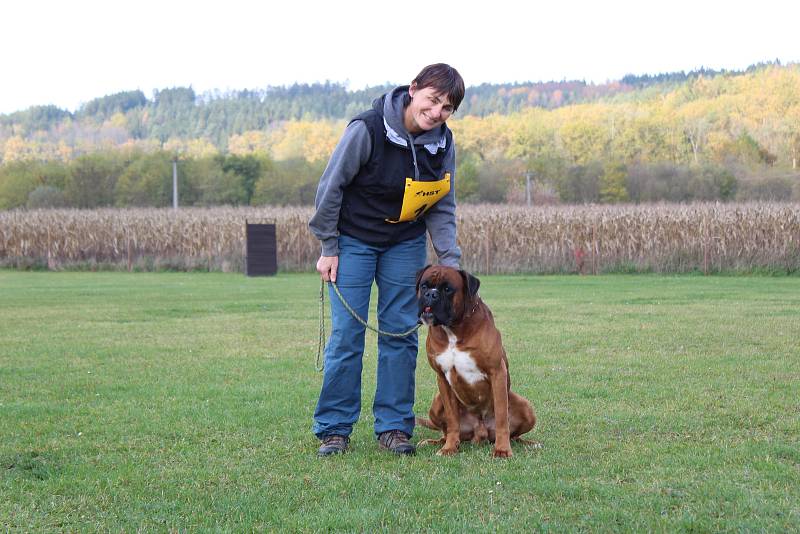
[0,150,322,209]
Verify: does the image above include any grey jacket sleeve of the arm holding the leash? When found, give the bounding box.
[308,120,372,256]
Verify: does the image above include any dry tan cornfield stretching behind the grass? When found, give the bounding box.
[0,203,800,274]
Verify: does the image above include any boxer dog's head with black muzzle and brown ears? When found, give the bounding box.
[417,265,481,326]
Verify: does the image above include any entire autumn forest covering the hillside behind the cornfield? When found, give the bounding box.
[0,62,800,209]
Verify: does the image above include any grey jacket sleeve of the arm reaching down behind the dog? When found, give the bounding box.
[425,143,461,268]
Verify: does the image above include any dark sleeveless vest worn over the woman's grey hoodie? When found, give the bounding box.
[339,105,454,245]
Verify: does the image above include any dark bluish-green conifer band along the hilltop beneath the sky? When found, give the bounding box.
[0,60,780,151]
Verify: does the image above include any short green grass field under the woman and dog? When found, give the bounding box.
[0,271,800,532]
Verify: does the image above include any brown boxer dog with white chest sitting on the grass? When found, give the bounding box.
[417,265,536,458]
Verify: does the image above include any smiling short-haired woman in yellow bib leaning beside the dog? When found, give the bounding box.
[309,63,464,456]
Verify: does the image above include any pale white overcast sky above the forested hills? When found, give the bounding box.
[0,0,800,113]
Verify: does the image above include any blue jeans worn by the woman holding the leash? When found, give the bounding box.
[313,234,426,439]
